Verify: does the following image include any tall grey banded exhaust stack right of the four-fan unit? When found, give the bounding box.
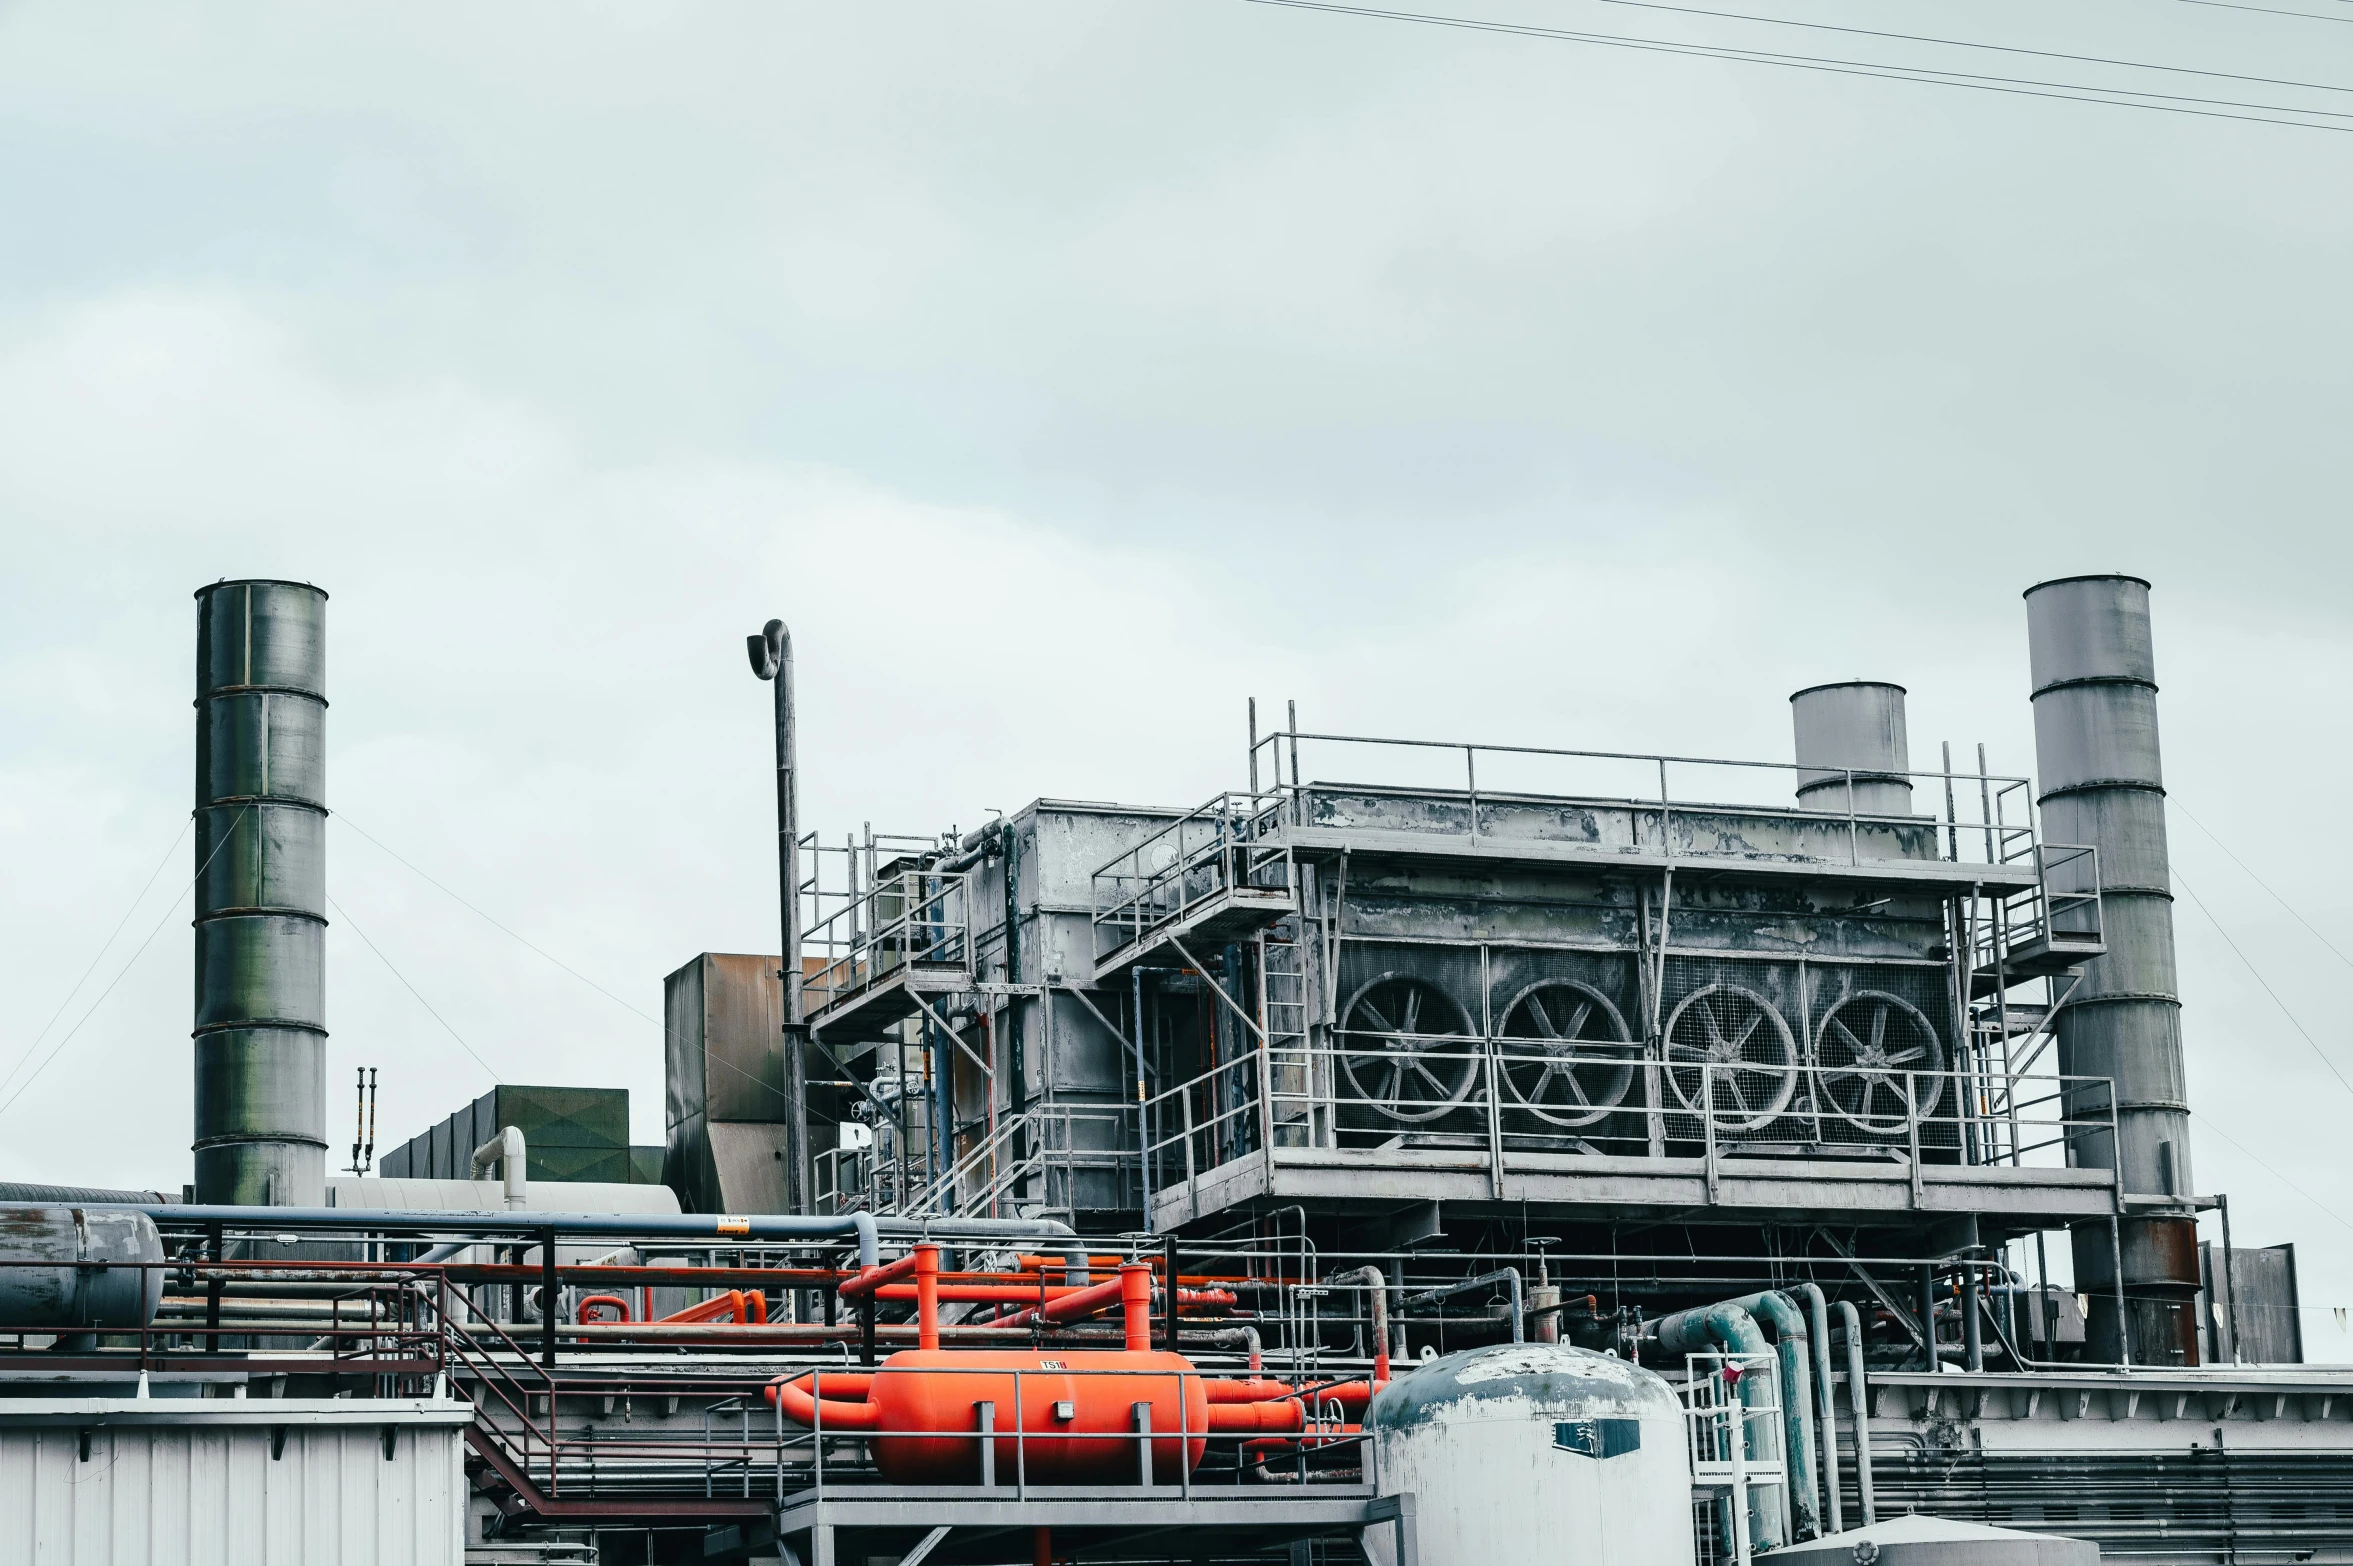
[2026,576,2198,1364]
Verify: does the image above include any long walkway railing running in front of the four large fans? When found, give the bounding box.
[1144,1035,2115,1194]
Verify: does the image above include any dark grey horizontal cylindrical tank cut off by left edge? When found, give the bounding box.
[0,1206,162,1331]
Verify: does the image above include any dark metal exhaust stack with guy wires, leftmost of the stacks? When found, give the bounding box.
[195,581,327,1206]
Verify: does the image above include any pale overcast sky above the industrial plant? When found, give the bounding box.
[0,0,2353,1357]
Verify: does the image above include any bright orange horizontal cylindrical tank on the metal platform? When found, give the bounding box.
[769,1350,1212,1484]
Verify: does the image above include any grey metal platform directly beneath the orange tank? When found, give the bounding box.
[776,1484,1419,1566]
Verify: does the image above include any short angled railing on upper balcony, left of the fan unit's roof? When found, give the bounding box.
[1092,795,1292,962]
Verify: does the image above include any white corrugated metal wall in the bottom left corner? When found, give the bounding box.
[0,1413,466,1566]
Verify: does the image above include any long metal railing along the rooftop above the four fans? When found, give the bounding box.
[1235,729,2035,865]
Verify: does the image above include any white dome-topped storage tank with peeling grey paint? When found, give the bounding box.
[1365,1343,1692,1566]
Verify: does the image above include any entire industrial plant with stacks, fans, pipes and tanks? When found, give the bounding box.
[0,576,2353,1566]
